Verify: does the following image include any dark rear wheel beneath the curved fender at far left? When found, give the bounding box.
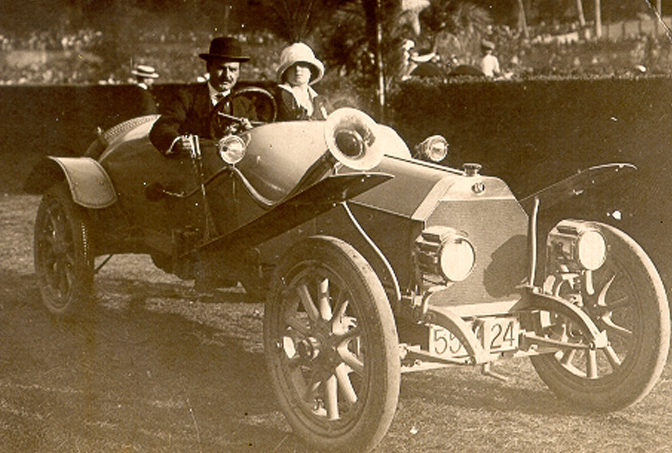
[33,181,95,317]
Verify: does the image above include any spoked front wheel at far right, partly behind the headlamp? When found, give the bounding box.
[532,224,670,411]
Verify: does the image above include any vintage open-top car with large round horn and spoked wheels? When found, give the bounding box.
[27,88,670,451]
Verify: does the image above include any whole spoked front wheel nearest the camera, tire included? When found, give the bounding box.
[264,236,400,451]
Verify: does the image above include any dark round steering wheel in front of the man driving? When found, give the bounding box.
[209,87,278,140]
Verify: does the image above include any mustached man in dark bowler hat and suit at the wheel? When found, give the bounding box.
[149,37,257,156]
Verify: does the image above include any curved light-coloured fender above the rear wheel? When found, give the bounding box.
[25,156,117,209]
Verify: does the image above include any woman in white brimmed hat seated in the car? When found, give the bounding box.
[277,42,327,121]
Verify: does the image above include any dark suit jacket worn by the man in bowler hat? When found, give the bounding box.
[149,83,257,154]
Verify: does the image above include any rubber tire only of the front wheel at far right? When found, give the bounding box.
[531,223,670,411]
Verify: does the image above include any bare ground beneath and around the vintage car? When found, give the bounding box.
[0,194,672,452]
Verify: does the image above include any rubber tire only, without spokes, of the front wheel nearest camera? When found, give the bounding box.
[264,236,401,452]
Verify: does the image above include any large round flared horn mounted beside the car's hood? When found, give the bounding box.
[324,107,383,170]
